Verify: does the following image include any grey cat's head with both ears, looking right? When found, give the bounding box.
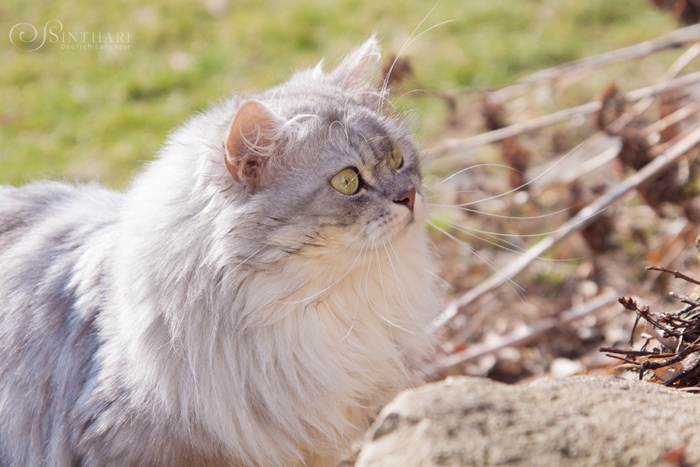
[217,38,425,251]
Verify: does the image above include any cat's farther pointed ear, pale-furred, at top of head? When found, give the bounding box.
[330,35,382,89]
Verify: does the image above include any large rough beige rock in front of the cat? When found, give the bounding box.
[356,376,700,467]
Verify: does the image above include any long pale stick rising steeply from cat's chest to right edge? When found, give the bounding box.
[433,124,700,329]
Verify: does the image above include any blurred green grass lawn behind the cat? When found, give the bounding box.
[0,0,675,187]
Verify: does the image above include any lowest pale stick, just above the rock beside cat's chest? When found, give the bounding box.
[437,290,620,369]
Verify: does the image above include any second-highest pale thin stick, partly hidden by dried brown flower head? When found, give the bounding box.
[429,70,700,159]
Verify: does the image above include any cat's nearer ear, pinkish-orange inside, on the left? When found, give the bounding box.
[225,100,282,191]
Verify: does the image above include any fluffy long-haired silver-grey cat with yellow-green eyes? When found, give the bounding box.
[0,39,438,467]
